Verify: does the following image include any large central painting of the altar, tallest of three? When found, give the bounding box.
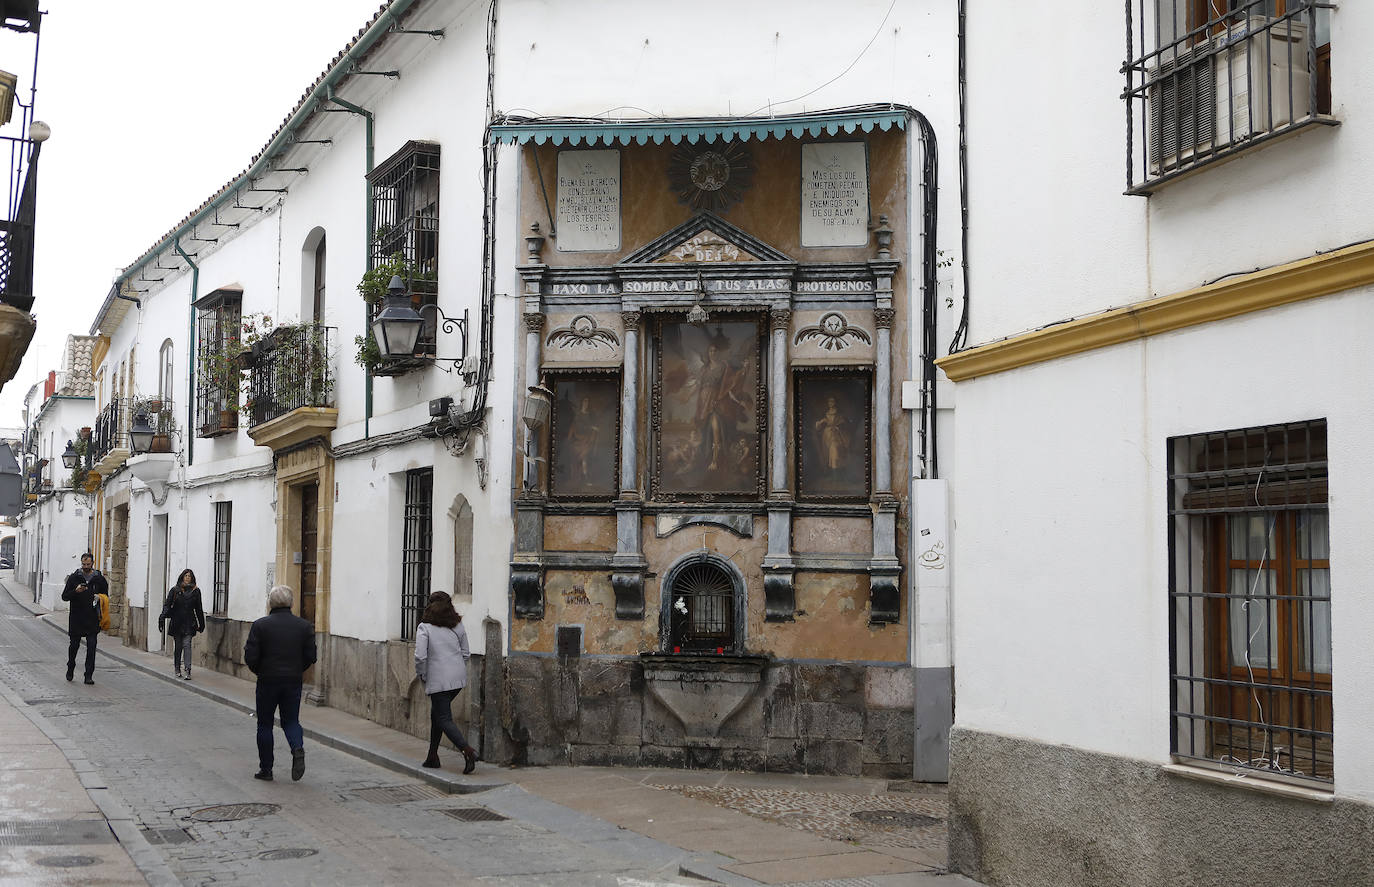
[654,317,764,498]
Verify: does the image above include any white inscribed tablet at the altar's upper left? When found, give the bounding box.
[556,151,620,253]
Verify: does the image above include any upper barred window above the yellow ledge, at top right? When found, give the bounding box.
[1121,0,1337,195]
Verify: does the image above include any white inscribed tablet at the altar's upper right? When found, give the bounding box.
[801,141,868,246]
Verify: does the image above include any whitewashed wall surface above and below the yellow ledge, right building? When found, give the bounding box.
[954,4,1374,799]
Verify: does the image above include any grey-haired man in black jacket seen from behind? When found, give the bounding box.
[243,585,315,780]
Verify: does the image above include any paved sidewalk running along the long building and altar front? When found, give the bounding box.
[0,578,978,887]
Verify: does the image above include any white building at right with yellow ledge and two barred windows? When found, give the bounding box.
[941,0,1374,887]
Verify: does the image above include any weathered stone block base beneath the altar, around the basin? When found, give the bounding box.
[491,655,915,779]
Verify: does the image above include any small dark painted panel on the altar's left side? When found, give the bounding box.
[550,373,620,498]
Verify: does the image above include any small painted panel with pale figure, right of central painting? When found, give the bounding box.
[796,371,871,500]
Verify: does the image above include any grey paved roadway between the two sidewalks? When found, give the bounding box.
[0,584,719,887]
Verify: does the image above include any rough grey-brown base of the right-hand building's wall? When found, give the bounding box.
[949,729,1374,887]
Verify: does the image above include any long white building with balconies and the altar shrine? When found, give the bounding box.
[50,0,958,780]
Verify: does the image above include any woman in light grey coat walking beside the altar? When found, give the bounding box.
[415,592,477,773]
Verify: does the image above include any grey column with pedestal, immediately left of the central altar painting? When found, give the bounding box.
[610,310,647,619]
